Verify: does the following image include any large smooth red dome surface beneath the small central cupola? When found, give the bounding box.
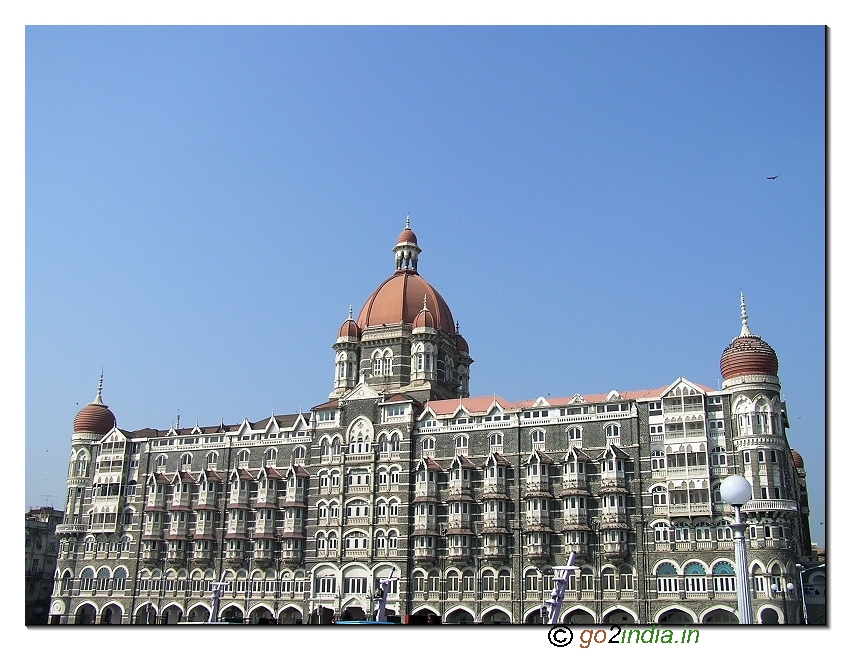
[357,270,455,335]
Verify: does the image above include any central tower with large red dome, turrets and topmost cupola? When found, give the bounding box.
[330,218,472,402]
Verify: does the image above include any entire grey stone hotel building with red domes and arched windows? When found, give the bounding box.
[50,221,824,625]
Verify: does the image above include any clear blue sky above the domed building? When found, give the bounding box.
[25,26,826,544]
